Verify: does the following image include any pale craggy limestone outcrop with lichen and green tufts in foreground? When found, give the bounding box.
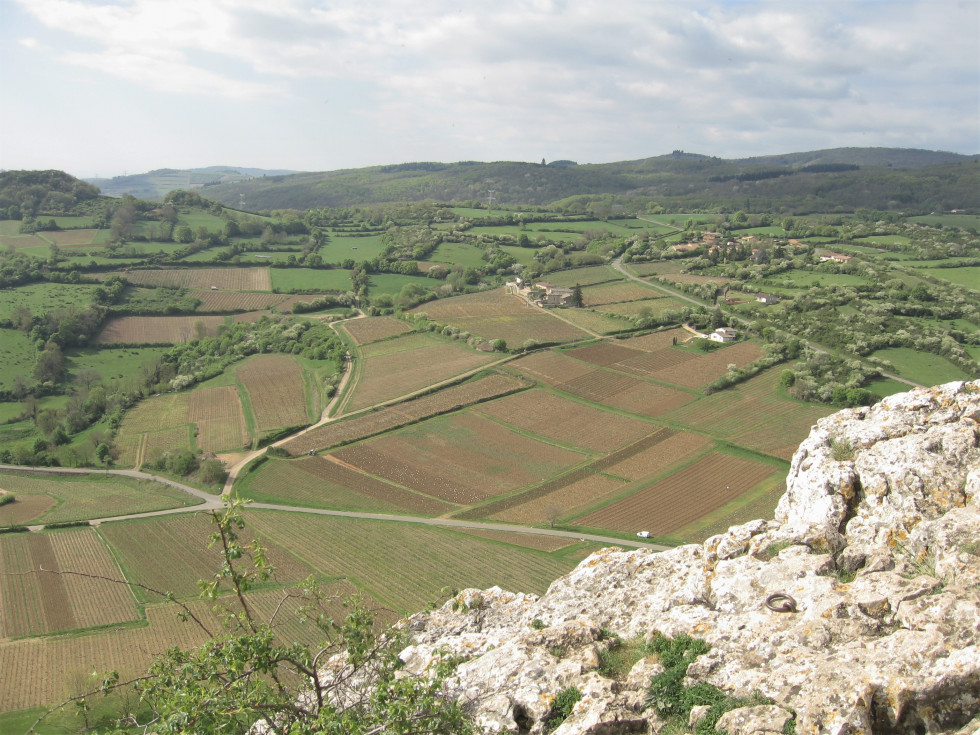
[401,382,980,735]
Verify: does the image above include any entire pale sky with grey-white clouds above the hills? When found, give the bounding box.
[0,0,980,176]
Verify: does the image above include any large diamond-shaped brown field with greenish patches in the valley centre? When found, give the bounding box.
[333,413,584,504]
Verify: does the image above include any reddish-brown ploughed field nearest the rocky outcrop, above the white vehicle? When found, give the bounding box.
[575,452,782,536]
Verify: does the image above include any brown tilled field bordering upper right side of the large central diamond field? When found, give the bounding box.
[476,390,655,452]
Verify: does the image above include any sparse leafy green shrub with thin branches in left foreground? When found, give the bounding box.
[31,501,472,735]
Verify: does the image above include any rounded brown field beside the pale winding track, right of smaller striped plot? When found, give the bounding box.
[235,355,310,431]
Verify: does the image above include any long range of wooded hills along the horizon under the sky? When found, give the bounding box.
[78,148,980,214]
